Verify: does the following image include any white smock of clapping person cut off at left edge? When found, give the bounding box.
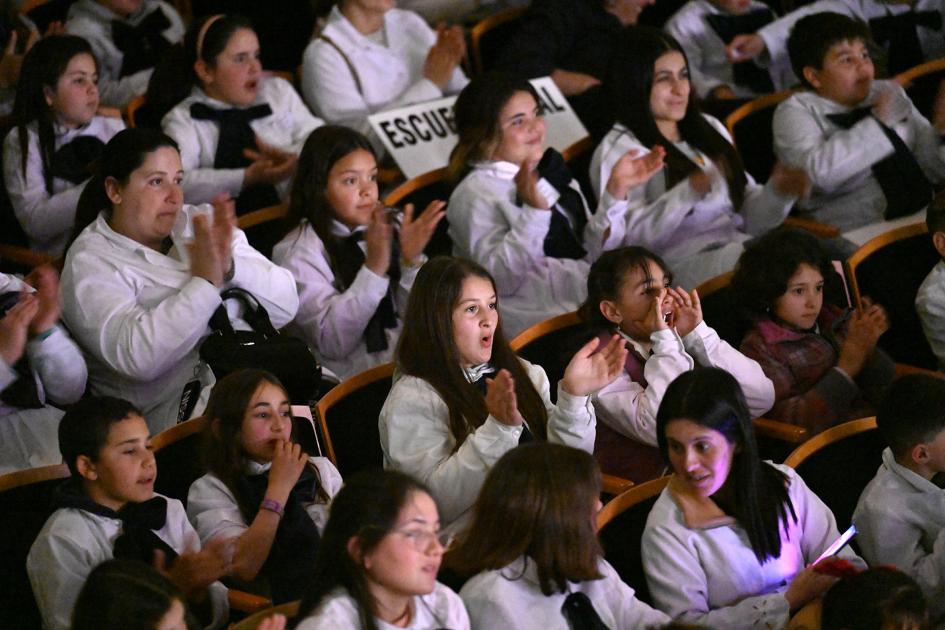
[0,273,88,474]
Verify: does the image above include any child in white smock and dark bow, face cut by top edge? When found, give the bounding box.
[663,0,789,100]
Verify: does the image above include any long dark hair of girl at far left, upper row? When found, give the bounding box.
[13,35,98,194]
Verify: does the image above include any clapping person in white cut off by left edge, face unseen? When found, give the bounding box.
[0,267,88,474]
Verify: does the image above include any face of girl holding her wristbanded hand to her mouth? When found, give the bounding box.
[240,382,292,463]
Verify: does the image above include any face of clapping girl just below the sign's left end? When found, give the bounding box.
[326,149,378,230]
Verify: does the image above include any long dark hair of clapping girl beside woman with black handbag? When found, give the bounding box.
[288,125,377,290]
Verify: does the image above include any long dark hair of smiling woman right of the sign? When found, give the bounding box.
[603,26,748,211]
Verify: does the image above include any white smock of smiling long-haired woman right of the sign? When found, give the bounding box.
[591,115,795,287]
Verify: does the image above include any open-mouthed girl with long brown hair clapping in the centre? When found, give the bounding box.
[379,257,626,531]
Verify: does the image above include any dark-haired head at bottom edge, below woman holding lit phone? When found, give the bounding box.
[820,567,931,630]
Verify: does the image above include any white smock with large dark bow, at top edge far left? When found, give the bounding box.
[65,0,185,108]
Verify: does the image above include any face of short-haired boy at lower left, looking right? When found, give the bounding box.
[80,415,157,511]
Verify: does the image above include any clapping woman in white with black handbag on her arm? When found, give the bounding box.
[61,129,298,433]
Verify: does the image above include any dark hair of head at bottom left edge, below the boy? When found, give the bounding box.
[72,559,200,630]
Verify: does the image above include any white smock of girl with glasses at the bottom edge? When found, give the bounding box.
[296,582,469,630]
